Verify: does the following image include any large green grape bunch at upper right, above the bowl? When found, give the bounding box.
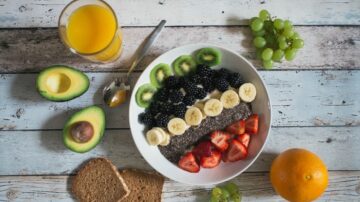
[250,10,304,69]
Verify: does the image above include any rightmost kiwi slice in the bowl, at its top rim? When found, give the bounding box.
[196,48,221,67]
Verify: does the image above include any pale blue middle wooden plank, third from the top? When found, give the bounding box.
[0,70,360,130]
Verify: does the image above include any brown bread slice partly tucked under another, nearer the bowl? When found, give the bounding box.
[120,169,164,202]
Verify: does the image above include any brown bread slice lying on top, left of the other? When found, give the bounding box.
[71,158,130,202]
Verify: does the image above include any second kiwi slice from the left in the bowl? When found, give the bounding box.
[150,63,172,88]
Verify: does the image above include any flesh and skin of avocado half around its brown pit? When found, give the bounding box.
[63,106,105,153]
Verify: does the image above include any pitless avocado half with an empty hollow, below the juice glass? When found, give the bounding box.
[36,65,90,102]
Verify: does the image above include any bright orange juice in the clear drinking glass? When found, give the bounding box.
[66,4,122,62]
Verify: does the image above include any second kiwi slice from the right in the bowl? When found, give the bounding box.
[172,55,196,76]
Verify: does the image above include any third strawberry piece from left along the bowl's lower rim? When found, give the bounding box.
[223,139,247,162]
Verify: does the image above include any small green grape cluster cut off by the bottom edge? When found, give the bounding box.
[210,182,241,202]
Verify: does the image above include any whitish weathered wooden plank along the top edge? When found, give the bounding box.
[0,0,360,27]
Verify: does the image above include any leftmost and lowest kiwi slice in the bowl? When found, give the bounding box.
[135,83,156,108]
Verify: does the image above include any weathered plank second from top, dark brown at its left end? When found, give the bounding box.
[0,26,360,72]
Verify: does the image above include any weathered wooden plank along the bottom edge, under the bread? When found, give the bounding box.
[0,171,360,202]
